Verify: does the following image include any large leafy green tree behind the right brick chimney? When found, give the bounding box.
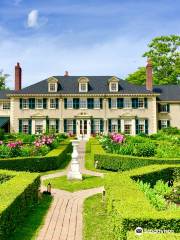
[127,35,180,85]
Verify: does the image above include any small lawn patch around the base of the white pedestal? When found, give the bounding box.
[43,175,104,192]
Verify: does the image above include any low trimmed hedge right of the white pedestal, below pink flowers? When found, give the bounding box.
[89,138,180,171]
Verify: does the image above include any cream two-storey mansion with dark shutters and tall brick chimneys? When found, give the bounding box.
[0,61,180,138]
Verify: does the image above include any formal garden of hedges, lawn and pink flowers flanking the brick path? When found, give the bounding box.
[0,128,180,240]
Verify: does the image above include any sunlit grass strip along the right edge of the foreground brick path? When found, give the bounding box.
[83,194,114,240]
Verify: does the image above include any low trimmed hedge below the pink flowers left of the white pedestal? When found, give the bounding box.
[0,140,72,172]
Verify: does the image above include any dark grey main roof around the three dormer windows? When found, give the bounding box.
[10,76,152,94]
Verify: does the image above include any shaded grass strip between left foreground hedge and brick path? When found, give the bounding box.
[8,196,52,240]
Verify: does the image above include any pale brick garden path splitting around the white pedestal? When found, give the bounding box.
[37,141,104,240]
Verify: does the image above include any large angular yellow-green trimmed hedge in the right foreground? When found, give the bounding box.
[105,165,180,240]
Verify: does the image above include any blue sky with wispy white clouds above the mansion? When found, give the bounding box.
[0,0,180,89]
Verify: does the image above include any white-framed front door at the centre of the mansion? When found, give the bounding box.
[77,119,90,139]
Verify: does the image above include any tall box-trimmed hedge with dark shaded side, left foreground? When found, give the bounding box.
[0,170,40,240]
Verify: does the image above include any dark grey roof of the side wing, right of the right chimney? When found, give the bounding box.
[153,85,180,101]
